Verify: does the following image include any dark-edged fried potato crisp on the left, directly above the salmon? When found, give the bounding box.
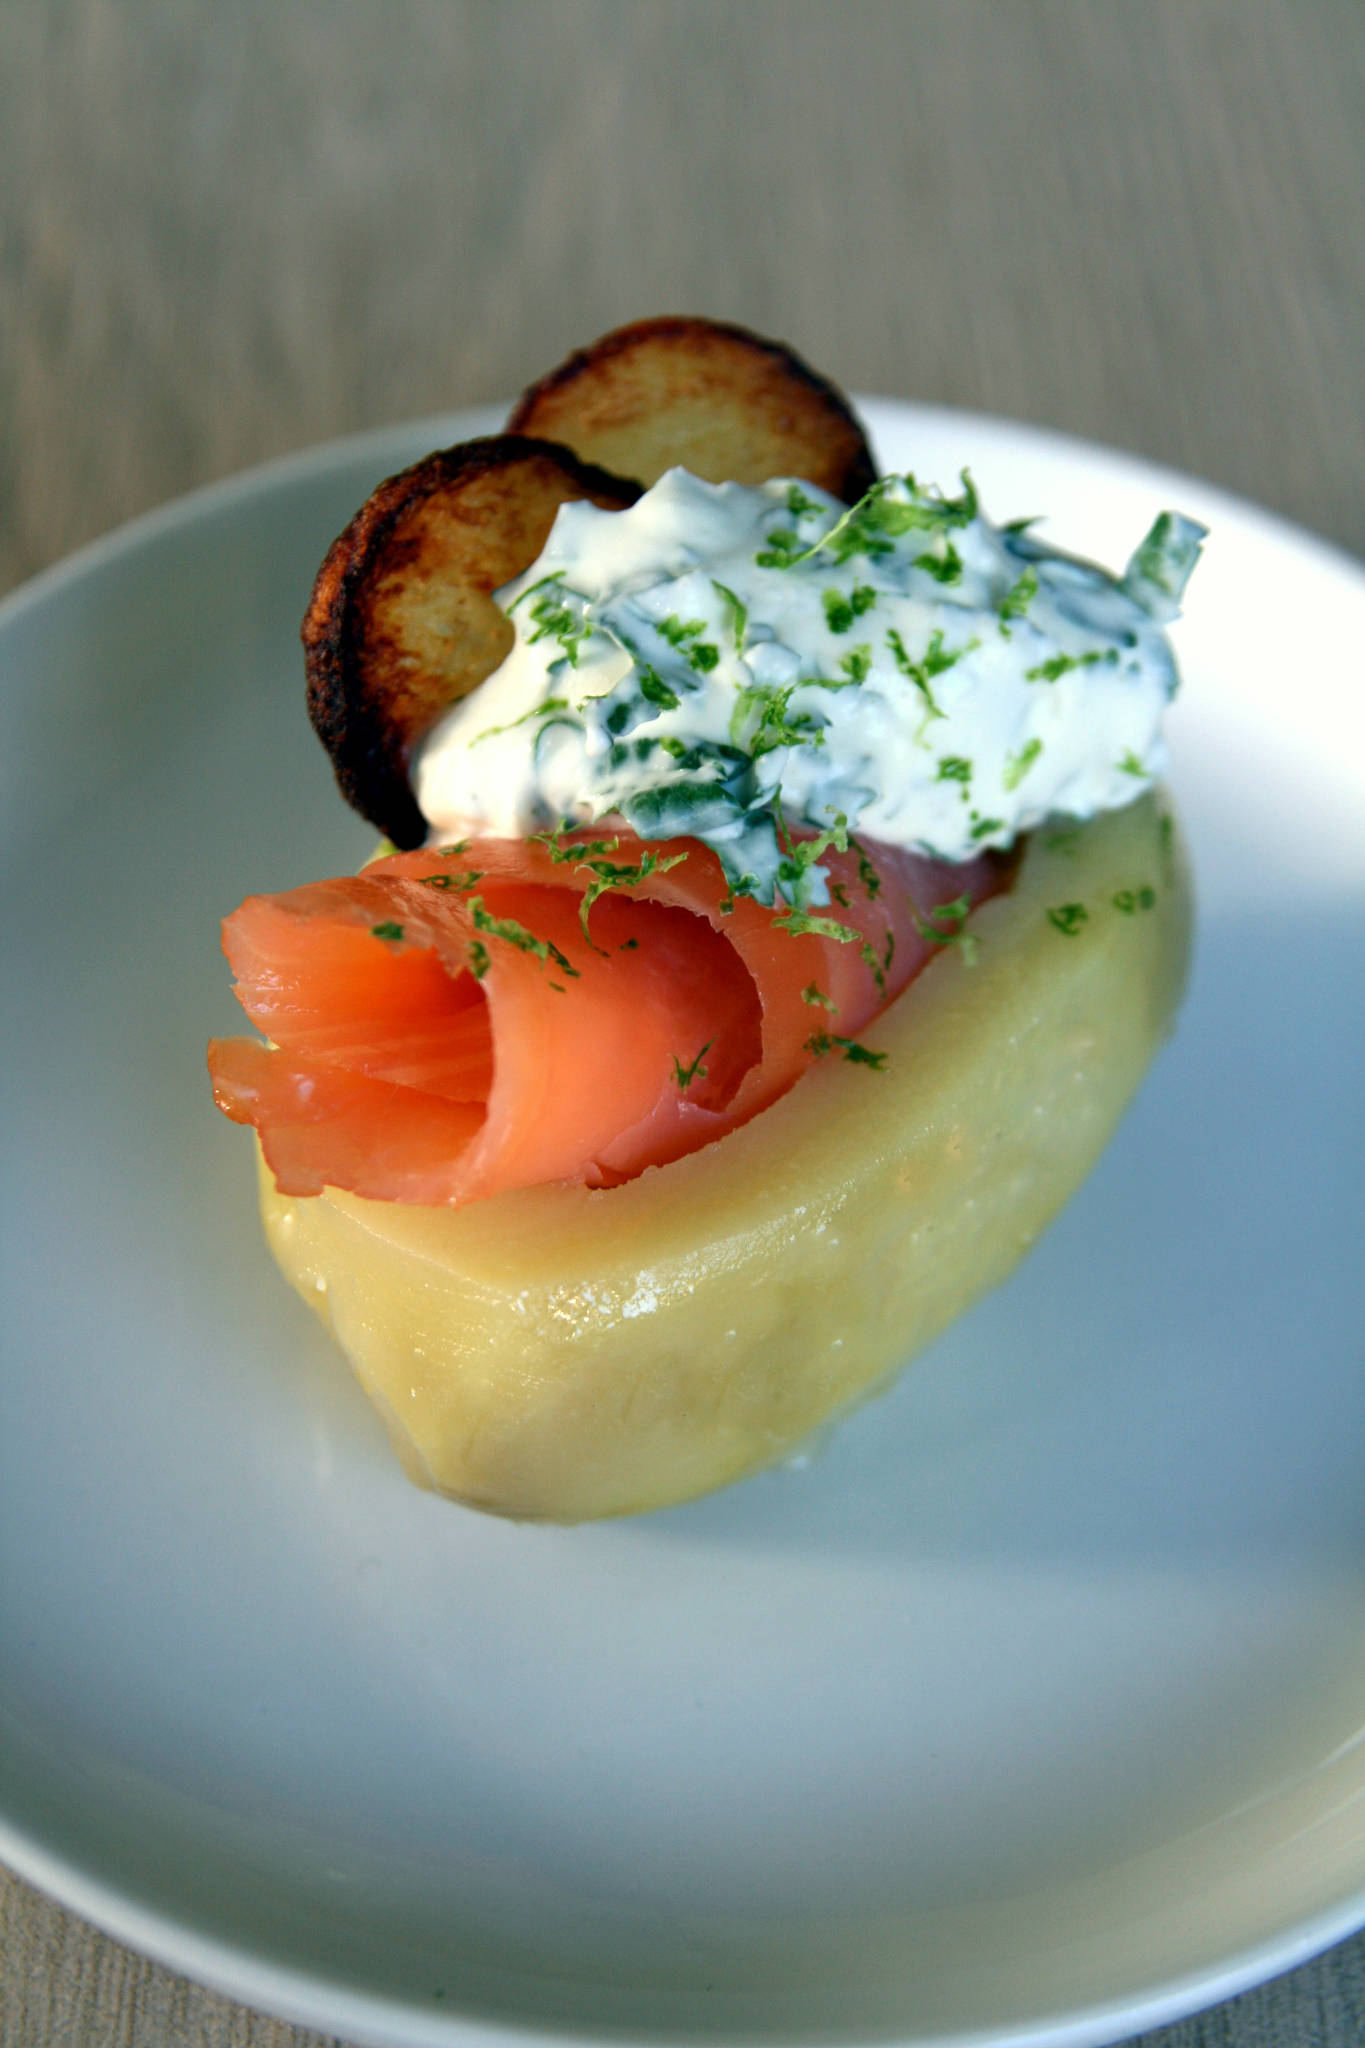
[303,434,641,848]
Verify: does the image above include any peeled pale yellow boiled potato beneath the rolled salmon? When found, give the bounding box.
[262,797,1191,1522]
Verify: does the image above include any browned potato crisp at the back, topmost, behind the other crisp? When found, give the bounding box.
[508,313,876,504]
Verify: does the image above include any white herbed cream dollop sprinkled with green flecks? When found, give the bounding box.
[413,469,1203,907]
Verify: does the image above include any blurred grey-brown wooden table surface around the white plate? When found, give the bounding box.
[0,0,1365,2048]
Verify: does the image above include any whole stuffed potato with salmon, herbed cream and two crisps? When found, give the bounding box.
[209,307,1201,1520]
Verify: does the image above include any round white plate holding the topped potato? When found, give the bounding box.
[0,403,1365,2044]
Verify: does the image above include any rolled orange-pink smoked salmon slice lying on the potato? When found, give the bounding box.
[209,831,1007,1204]
